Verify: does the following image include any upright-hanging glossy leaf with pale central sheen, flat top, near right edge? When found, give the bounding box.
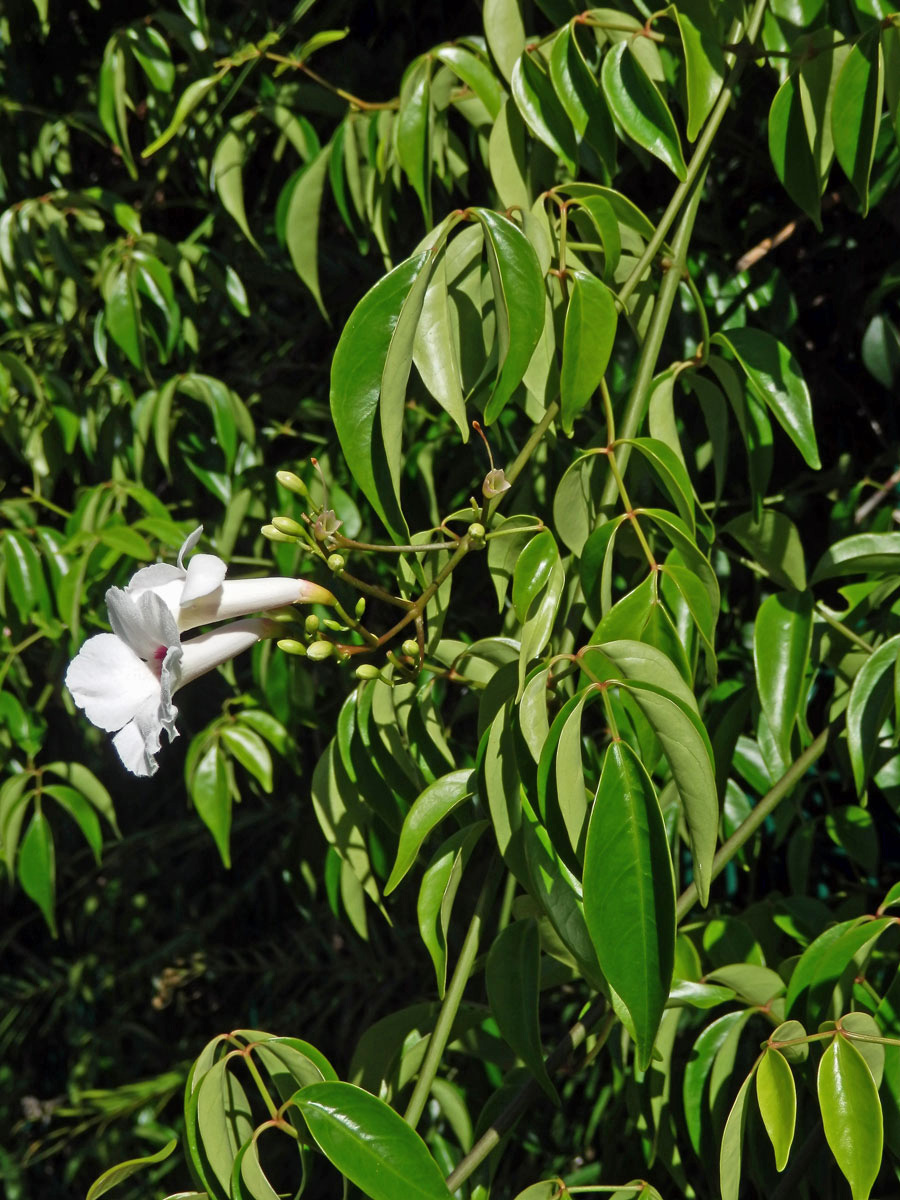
[754,592,812,760]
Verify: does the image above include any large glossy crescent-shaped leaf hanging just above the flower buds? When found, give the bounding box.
[331,251,433,541]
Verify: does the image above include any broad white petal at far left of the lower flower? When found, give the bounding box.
[66,634,160,733]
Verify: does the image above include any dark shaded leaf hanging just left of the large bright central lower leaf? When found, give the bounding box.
[485,920,559,1105]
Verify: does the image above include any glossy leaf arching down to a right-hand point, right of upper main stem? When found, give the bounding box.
[712,326,822,470]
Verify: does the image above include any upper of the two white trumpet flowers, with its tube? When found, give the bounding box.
[122,526,335,634]
